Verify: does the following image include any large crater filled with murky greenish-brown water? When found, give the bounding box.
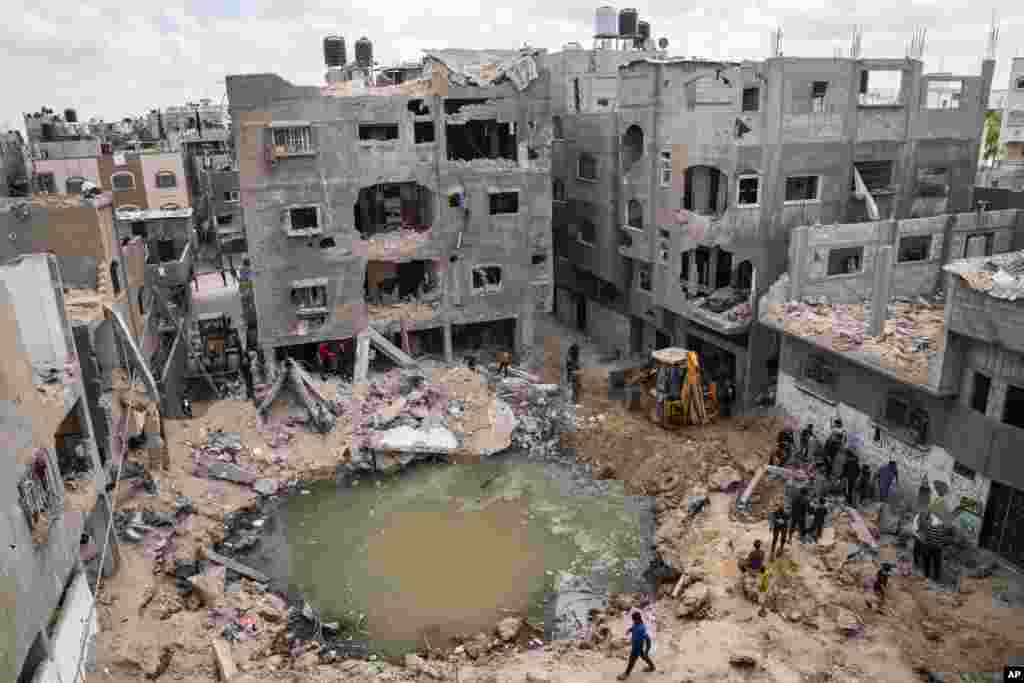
[231,454,654,657]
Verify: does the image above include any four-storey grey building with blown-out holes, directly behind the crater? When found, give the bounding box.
[227,44,552,372]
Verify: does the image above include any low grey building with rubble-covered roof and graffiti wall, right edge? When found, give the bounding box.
[759,210,1024,564]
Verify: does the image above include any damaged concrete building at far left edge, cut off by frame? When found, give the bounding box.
[0,254,117,681]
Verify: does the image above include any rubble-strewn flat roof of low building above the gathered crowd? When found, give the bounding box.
[761,286,945,387]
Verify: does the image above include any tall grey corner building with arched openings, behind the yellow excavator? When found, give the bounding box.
[545,49,994,405]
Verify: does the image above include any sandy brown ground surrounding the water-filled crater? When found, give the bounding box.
[88,317,1024,683]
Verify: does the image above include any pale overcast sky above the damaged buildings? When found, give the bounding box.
[0,0,1024,132]
